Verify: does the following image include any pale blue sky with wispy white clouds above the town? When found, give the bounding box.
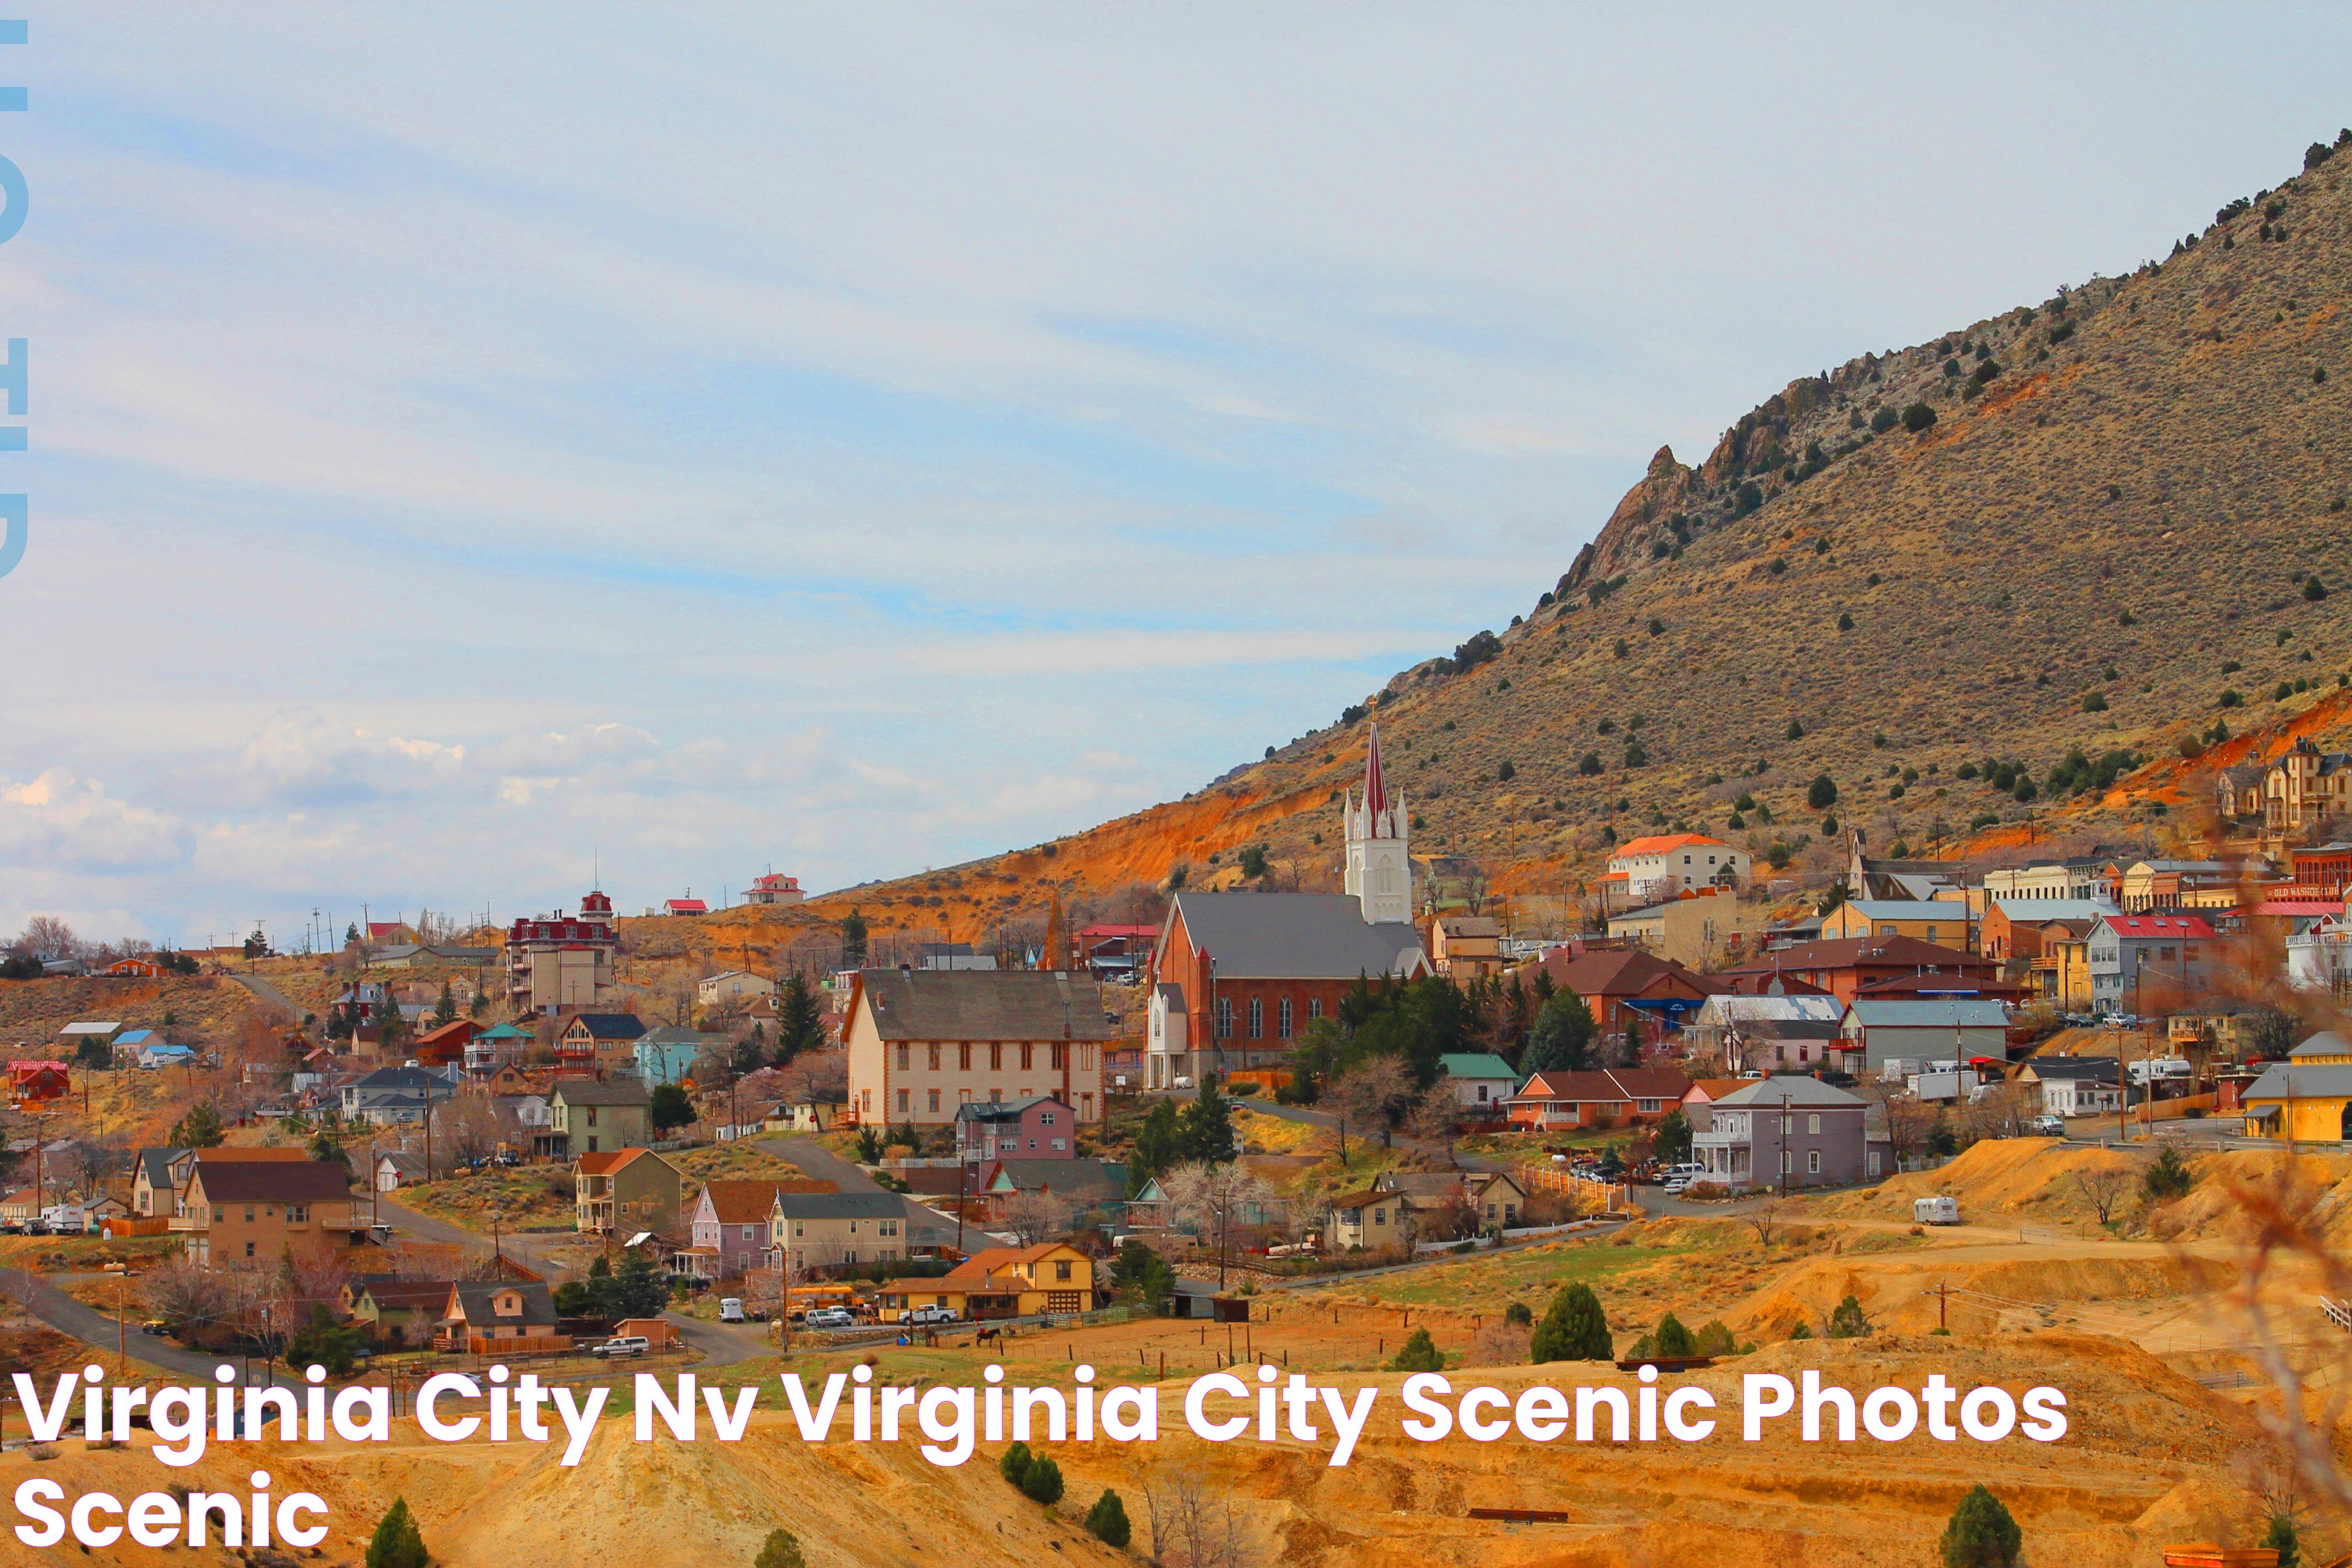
[0,5,2352,940]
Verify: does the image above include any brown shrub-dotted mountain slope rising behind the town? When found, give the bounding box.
[687,143,2352,935]
